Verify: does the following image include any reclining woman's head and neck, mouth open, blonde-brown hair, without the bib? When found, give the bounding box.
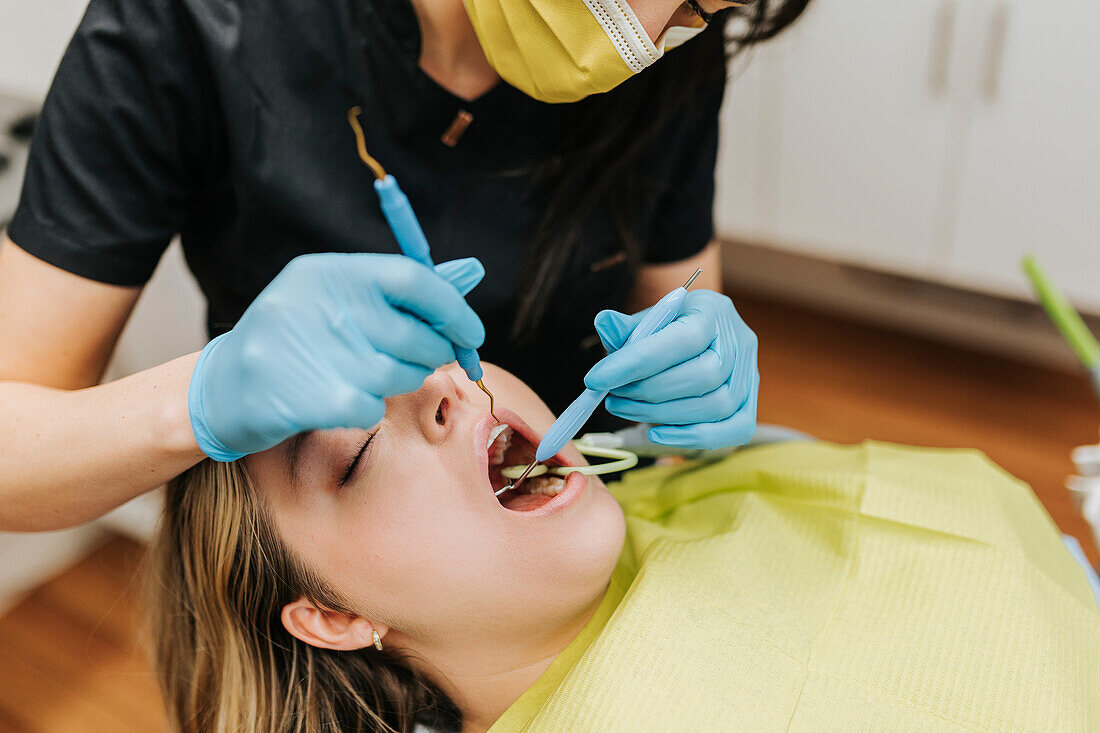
[150,364,624,731]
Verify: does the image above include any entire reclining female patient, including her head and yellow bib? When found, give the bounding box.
[152,365,1100,732]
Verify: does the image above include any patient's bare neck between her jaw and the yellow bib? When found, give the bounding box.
[411,595,603,733]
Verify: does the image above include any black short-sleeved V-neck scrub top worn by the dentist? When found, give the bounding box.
[15,0,721,420]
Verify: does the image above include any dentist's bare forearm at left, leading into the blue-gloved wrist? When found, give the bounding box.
[0,353,204,532]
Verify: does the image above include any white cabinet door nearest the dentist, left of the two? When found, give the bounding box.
[739,0,969,274]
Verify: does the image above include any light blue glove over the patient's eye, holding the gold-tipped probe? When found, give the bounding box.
[188,254,485,461]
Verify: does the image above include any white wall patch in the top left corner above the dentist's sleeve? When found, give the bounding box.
[0,0,87,99]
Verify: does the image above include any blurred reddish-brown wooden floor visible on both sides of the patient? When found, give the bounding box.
[0,297,1100,733]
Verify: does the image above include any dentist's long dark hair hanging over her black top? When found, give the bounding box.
[510,0,810,342]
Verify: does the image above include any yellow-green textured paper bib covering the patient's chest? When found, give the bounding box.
[492,435,1100,733]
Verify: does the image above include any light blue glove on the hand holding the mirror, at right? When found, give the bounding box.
[584,289,760,449]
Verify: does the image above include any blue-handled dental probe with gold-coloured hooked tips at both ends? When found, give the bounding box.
[348,107,501,423]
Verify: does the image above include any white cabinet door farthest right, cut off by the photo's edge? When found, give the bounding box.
[950,0,1100,313]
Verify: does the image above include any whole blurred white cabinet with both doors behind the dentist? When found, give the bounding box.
[716,0,1100,313]
